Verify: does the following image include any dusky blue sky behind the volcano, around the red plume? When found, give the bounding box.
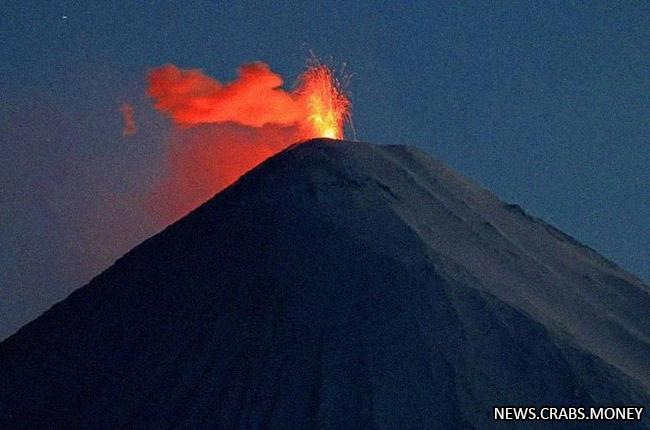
[0,0,650,339]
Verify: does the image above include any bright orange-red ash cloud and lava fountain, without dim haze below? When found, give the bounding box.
[148,62,350,139]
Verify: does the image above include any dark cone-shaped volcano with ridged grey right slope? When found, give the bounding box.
[0,139,650,429]
